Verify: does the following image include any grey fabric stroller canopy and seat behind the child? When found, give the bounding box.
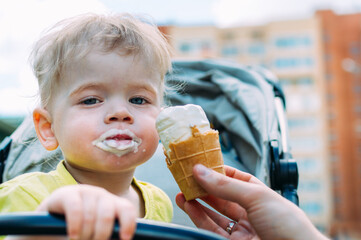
[0,60,298,236]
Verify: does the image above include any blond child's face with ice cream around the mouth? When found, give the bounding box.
[50,51,160,172]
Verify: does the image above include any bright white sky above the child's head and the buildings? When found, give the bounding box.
[0,0,361,117]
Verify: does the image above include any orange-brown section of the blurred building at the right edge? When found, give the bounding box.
[316,11,361,238]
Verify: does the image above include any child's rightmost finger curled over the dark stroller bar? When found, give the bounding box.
[115,199,137,240]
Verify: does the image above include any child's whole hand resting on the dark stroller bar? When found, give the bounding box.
[37,185,137,239]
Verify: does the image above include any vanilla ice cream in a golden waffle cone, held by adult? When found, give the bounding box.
[156,104,224,201]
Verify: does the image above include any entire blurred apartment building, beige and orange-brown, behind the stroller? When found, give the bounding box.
[162,11,361,236]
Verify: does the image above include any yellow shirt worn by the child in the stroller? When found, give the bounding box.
[0,161,173,222]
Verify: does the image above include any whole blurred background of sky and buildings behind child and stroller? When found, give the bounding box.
[0,0,361,239]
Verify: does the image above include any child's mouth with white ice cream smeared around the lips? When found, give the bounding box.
[92,129,142,157]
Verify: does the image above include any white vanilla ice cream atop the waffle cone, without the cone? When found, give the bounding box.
[156,104,211,156]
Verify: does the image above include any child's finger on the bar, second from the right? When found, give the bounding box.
[94,197,115,239]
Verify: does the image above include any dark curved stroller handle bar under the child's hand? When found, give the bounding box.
[0,212,225,240]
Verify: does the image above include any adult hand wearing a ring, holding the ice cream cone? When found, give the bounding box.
[176,164,326,239]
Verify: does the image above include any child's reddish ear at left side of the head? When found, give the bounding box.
[33,108,59,151]
